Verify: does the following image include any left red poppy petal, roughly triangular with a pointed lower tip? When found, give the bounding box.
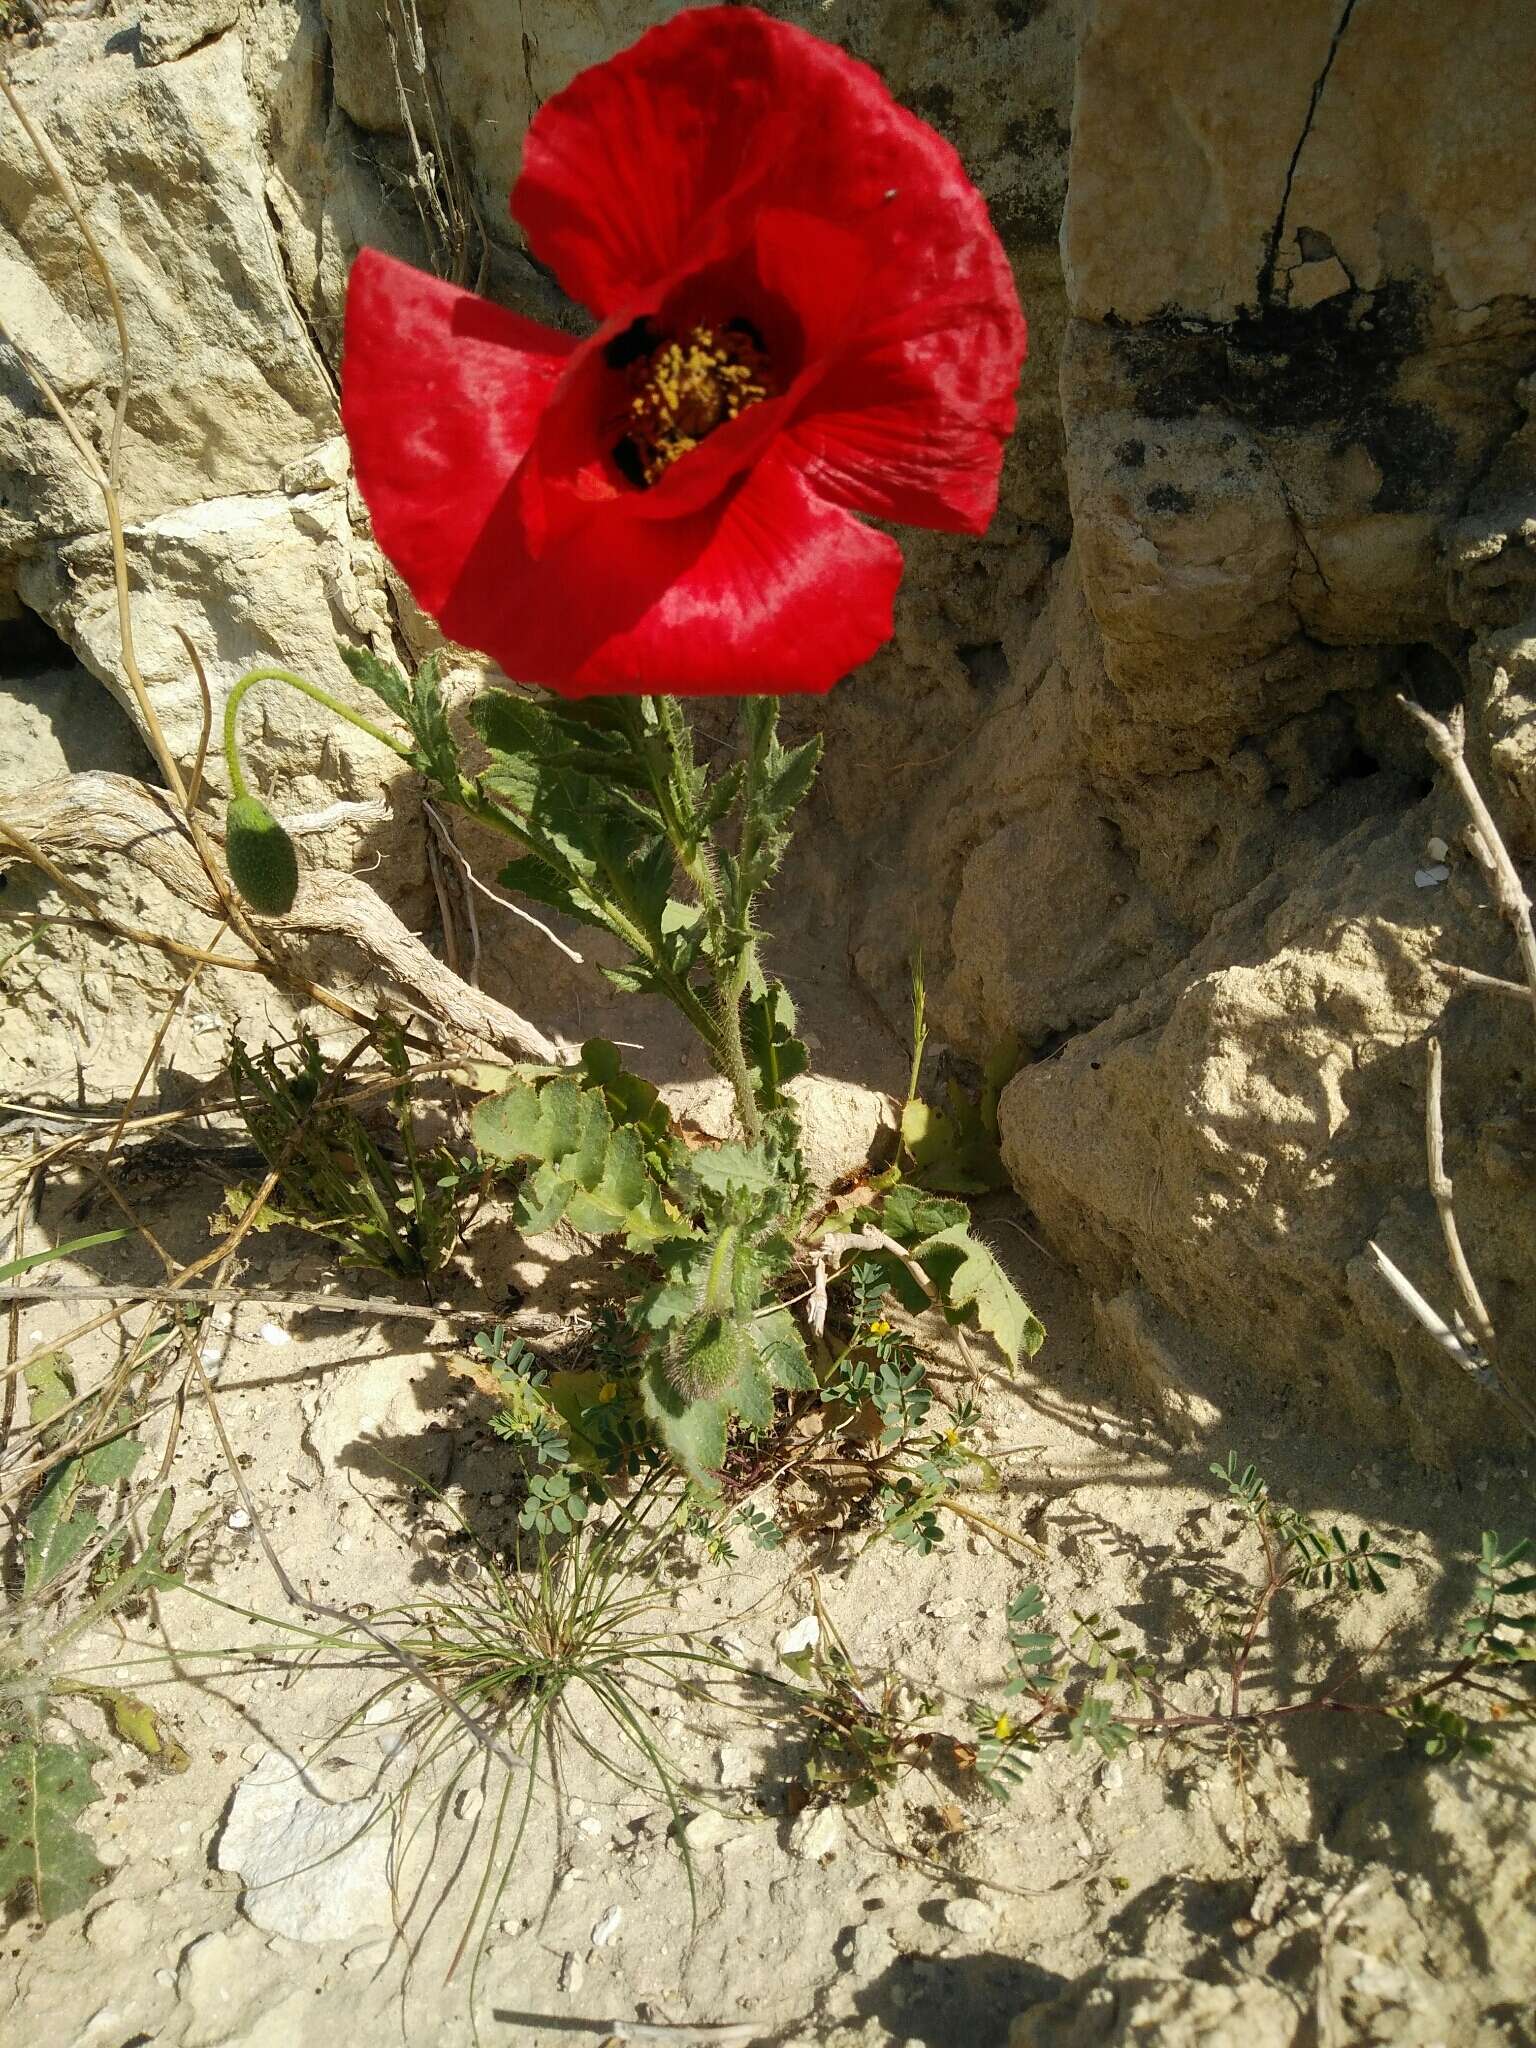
[342,250,578,616]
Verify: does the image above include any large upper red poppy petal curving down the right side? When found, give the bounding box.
[512,6,1024,532]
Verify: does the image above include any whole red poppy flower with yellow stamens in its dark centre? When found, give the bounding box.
[342,6,1024,696]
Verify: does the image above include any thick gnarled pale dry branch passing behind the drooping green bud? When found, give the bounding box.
[2,774,561,1065]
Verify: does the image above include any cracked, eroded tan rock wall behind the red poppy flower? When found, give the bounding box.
[0,0,1536,1425]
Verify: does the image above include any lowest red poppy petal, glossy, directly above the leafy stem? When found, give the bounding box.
[436,461,901,696]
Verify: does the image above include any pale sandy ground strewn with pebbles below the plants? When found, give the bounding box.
[0,1167,1536,2048]
